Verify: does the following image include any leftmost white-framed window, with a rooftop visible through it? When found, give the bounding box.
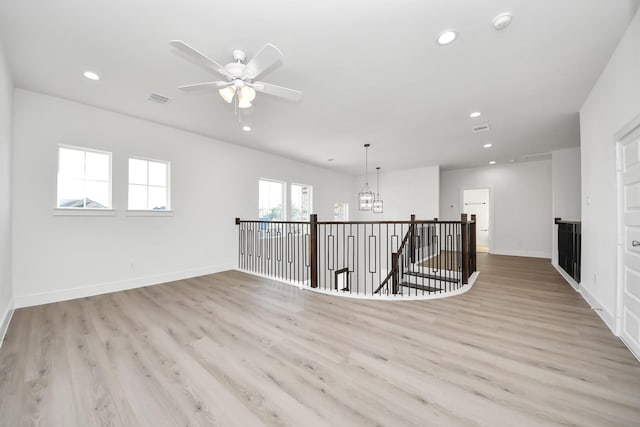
[56,146,111,209]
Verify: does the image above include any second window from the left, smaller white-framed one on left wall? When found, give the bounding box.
[129,157,169,211]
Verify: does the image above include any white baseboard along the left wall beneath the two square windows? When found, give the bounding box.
[15,265,235,308]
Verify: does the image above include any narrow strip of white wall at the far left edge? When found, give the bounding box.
[0,36,13,346]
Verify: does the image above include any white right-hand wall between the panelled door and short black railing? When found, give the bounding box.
[580,9,640,331]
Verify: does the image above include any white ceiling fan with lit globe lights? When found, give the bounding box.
[169,40,302,108]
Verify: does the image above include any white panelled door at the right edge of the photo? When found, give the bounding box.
[617,120,640,357]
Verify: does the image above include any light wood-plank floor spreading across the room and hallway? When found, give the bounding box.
[0,254,640,427]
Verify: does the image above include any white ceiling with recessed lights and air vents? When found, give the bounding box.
[0,0,638,174]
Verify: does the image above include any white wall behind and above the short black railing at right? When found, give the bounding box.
[551,147,581,265]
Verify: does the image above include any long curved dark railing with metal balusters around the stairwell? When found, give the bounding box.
[236,214,475,297]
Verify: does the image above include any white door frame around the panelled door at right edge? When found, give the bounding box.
[614,114,640,337]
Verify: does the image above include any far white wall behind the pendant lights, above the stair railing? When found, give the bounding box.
[350,166,440,221]
